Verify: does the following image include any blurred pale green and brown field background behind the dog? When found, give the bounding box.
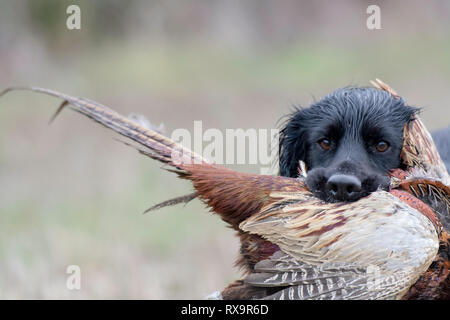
[0,0,450,299]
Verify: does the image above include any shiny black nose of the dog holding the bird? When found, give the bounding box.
[325,174,361,201]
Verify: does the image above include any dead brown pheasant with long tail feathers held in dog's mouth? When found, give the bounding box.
[0,81,450,299]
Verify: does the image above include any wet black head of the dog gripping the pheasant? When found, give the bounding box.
[279,87,418,202]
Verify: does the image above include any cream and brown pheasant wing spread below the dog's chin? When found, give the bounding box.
[240,191,439,299]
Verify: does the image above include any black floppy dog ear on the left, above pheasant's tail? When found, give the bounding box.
[278,109,308,178]
